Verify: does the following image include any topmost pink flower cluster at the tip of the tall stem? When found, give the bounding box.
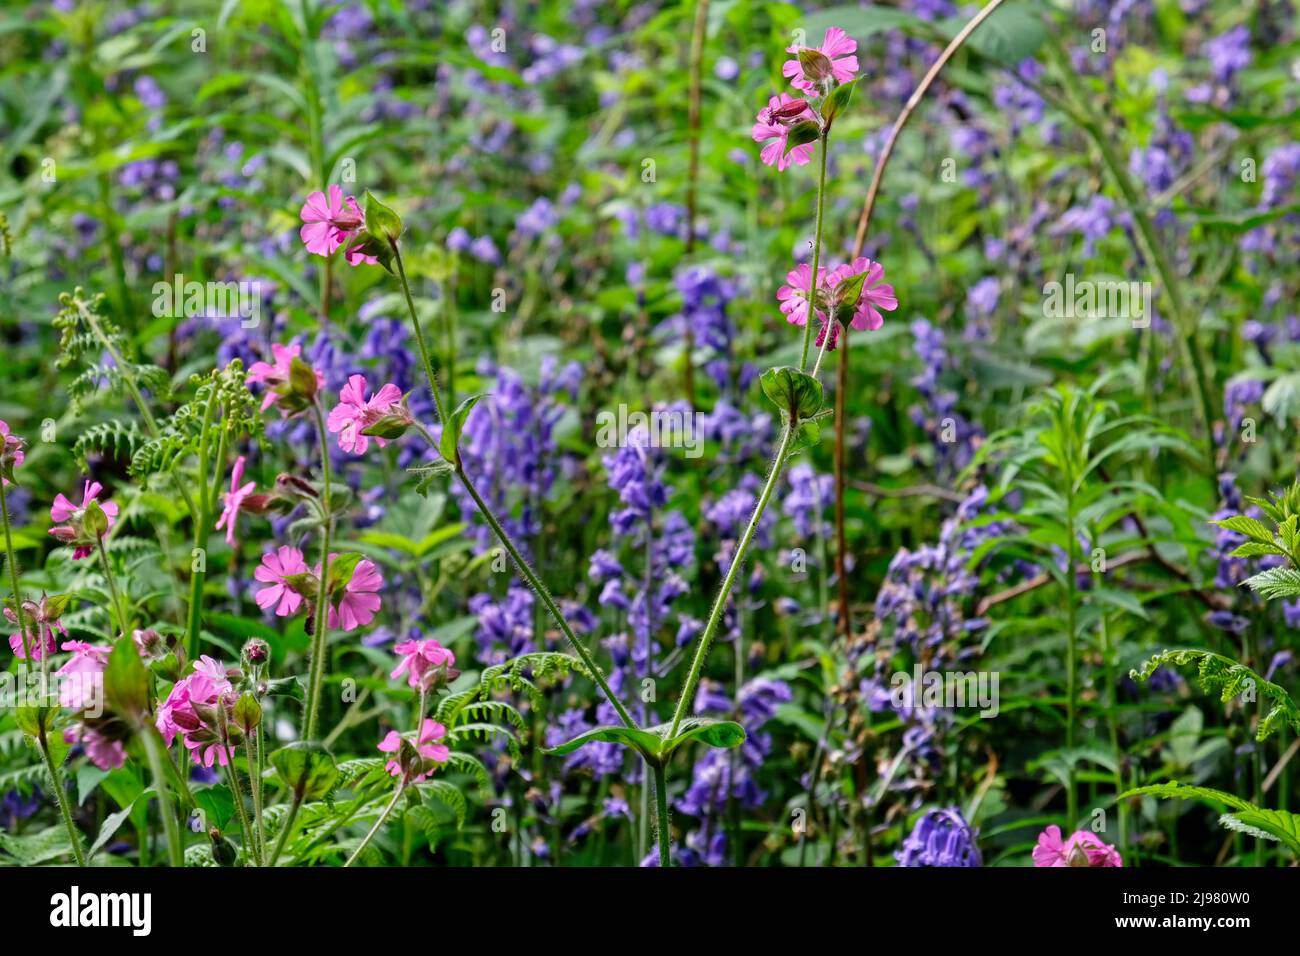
[750,26,858,170]
